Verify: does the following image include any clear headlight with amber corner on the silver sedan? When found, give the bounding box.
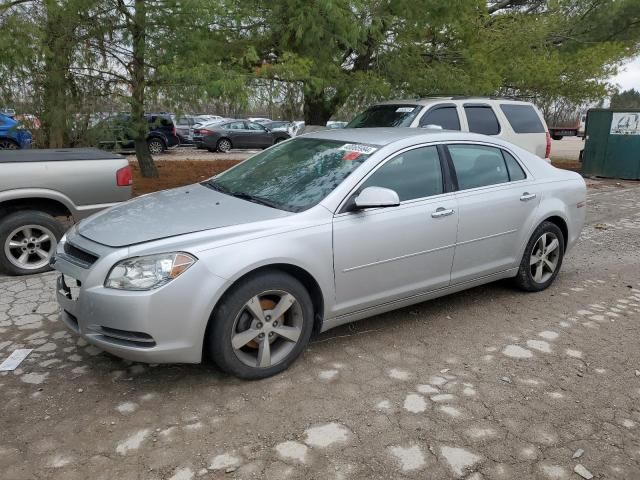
[104,252,197,290]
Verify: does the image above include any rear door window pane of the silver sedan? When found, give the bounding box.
[448,145,509,190]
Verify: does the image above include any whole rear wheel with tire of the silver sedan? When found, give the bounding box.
[515,221,565,292]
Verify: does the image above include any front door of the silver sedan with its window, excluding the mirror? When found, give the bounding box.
[333,146,458,315]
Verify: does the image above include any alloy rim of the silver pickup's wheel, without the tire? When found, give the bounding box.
[4,225,58,270]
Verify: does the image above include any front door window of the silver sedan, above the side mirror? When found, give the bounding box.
[361,147,444,202]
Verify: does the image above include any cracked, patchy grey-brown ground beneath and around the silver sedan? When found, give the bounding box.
[0,183,640,480]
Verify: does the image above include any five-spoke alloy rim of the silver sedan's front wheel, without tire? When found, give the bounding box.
[230,290,304,368]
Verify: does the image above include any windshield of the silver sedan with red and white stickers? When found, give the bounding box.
[204,138,377,212]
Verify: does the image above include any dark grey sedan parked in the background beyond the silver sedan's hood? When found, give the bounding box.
[201,120,291,152]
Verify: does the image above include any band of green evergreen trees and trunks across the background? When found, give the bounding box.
[0,0,640,175]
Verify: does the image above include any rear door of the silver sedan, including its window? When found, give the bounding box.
[447,143,540,284]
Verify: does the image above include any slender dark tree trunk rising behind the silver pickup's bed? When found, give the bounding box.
[130,0,158,178]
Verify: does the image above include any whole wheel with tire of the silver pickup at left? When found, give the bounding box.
[0,210,65,275]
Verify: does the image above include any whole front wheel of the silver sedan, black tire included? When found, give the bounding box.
[205,271,314,380]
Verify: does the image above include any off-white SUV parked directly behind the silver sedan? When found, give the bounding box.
[346,97,551,162]
